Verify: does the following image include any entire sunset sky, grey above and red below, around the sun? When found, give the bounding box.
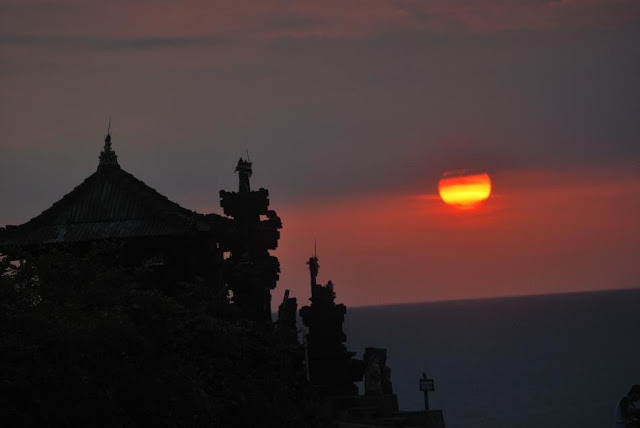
[0,0,640,309]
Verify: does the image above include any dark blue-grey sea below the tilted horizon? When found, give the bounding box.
[345,289,640,428]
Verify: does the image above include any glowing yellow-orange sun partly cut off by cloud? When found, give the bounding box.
[438,173,491,208]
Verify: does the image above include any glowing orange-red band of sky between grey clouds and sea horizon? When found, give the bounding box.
[270,167,640,306]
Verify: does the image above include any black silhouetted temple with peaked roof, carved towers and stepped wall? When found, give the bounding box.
[0,132,444,427]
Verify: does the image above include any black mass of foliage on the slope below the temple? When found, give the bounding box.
[0,246,327,427]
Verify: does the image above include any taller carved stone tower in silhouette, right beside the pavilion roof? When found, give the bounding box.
[220,158,282,322]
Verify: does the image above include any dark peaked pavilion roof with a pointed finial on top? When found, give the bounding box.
[0,136,225,249]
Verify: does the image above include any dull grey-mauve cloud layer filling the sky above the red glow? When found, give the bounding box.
[0,0,640,223]
